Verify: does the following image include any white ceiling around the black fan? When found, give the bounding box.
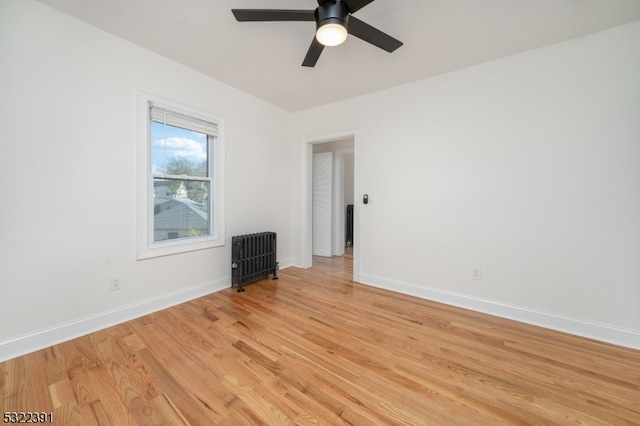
[33,0,640,111]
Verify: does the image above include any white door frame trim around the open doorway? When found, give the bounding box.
[300,130,360,282]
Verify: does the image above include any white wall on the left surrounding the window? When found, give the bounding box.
[0,0,297,360]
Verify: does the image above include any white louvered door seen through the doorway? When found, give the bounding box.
[312,152,333,257]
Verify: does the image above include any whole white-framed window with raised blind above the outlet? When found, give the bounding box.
[138,92,224,259]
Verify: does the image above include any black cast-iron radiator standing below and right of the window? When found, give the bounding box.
[231,232,278,292]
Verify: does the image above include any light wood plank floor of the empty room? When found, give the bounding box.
[0,257,640,426]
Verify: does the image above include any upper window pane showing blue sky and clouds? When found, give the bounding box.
[151,121,208,177]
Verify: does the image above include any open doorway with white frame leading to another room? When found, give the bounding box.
[302,133,359,281]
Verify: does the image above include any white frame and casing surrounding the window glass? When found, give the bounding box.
[137,91,225,259]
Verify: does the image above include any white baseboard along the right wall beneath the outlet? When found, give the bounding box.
[360,274,640,349]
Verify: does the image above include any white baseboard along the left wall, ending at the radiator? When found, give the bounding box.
[0,277,231,362]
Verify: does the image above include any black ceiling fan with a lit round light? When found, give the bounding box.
[231,0,402,67]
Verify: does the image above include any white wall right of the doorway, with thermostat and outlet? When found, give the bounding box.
[293,22,640,348]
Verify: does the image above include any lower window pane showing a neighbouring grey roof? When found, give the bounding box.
[153,178,211,242]
